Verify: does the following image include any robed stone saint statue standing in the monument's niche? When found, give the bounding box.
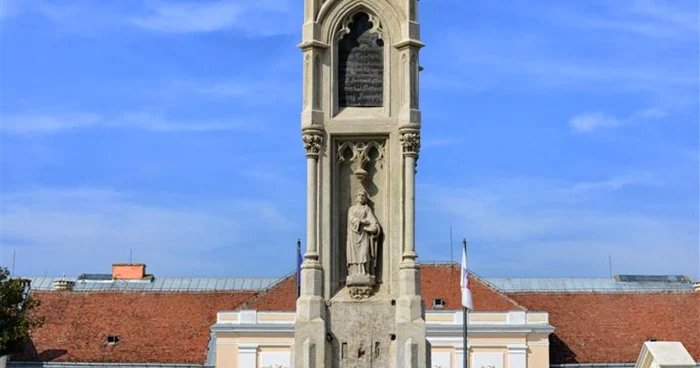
[347,189,381,276]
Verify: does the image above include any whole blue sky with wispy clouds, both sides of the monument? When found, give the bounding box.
[0,0,700,278]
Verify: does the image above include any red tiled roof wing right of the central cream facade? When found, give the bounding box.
[509,292,700,364]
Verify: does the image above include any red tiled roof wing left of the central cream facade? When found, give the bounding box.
[19,292,256,364]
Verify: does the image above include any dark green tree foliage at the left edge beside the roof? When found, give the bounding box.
[0,267,44,355]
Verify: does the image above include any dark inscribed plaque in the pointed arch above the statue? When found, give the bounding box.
[338,13,384,107]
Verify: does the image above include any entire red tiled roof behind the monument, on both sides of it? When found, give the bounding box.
[14,264,700,364]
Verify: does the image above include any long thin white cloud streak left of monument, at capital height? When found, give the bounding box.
[2,112,259,135]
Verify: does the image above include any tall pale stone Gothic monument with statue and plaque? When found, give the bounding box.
[294,0,429,368]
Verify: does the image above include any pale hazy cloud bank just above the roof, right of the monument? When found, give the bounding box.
[417,179,700,277]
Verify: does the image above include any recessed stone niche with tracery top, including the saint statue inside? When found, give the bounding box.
[337,140,386,299]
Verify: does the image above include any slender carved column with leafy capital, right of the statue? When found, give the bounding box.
[399,130,420,263]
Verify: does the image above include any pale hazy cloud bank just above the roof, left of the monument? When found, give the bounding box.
[1,188,302,275]
